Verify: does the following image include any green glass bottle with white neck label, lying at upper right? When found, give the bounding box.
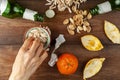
[90,0,120,15]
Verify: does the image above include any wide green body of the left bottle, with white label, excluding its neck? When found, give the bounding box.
[0,0,21,18]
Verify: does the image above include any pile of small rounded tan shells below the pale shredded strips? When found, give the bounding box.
[63,6,92,35]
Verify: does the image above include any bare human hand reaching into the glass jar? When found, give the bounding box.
[9,38,48,80]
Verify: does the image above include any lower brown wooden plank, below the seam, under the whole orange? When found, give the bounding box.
[0,45,120,80]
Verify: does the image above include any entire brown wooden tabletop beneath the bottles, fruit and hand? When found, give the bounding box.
[0,0,120,80]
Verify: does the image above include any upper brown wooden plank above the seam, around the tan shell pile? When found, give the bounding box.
[0,0,120,44]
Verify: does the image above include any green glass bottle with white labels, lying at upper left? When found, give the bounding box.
[0,0,44,22]
